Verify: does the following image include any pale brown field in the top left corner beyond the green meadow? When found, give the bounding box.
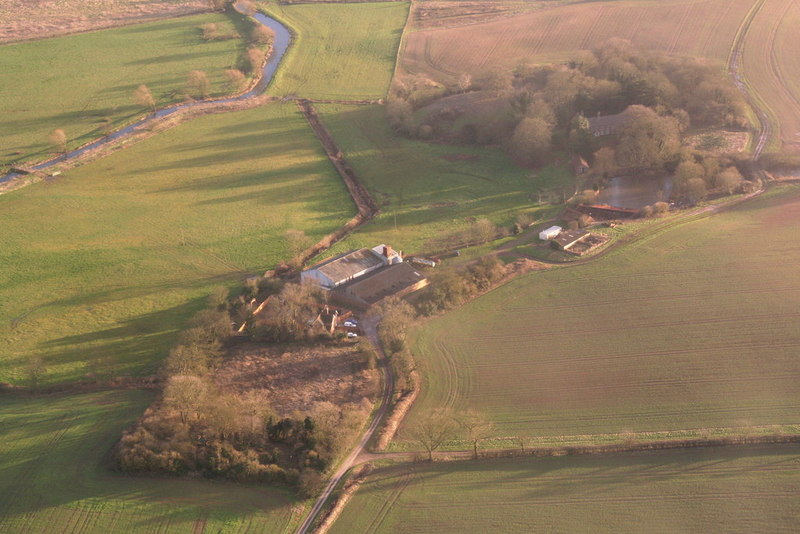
[0,0,210,43]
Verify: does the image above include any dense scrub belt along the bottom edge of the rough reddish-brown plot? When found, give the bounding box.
[117,390,369,491]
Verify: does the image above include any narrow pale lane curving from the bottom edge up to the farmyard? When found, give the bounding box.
[295,317,394,534]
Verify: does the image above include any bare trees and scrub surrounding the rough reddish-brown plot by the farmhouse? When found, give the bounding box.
[116,284,368,495]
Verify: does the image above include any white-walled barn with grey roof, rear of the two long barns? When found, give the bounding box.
[300,245,403,289]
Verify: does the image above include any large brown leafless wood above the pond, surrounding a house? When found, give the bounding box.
[386,39,749,174]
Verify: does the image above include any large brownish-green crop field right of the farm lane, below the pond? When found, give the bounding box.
[409,185,800,441]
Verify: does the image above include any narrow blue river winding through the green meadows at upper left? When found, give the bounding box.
[0,5,292,184]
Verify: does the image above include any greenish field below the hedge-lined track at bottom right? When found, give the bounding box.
[331,447,800,534]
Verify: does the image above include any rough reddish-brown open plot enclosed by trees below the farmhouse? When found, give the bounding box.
[215,344,380,416]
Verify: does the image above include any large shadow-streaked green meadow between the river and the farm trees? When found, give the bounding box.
[0,104,355,384]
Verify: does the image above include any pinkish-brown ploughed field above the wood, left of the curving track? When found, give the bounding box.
[403,0,753,78]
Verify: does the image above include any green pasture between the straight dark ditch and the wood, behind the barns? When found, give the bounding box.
[318,105,573,252]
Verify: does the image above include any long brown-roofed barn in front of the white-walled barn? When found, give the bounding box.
[333,263,428,307]
